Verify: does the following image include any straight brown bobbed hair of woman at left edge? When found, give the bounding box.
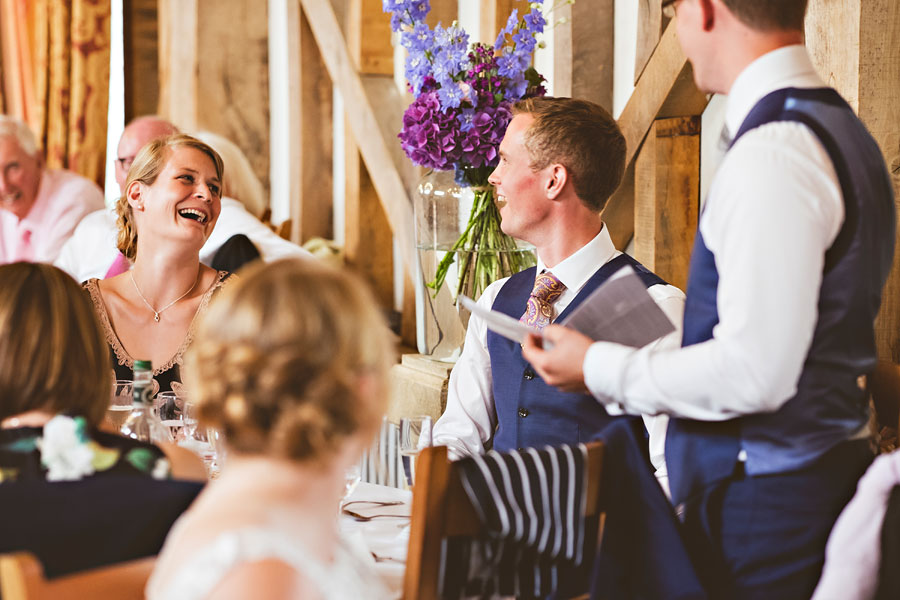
[0,263,112,425]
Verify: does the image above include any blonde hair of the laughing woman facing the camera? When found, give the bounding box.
[116,133,225,261]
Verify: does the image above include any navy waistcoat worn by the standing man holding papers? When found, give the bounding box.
[666,88,896,503]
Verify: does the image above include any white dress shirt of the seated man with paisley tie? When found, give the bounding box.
[433,225,684,488]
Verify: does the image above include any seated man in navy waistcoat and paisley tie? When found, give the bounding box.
[434,97,684,482]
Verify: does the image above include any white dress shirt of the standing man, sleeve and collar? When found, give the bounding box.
[584,46,844,421]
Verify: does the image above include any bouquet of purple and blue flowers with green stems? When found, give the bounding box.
[382,0,546,302]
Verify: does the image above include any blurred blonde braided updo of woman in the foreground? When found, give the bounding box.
[185,259,393,463]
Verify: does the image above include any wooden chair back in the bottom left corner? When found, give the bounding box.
[0,552,156,600]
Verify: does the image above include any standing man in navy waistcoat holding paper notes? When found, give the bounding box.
[524,0,896,599]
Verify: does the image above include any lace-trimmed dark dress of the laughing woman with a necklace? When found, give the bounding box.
[82,271,231,392]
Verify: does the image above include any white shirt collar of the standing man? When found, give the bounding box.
[725,44,825,136]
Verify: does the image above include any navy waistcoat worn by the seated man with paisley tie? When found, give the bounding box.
[487,254,665,452]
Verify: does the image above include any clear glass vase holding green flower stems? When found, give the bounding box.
[415,171,535,361]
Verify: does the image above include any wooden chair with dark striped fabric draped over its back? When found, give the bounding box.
[403,442,603,600]
